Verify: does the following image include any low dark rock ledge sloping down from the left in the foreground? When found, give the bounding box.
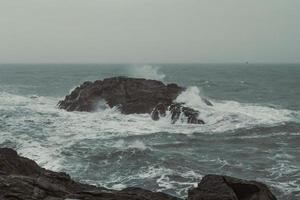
[0,148,179,200]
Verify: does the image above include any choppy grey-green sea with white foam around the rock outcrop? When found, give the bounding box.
[0,64,300,200]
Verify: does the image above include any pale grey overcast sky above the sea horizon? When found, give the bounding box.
[0,0,300,63]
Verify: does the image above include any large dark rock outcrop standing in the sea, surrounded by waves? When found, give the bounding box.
[58,77,212,124]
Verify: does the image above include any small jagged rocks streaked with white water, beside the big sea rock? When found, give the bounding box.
[151,103,204,124]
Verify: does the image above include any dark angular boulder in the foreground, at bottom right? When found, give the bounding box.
[188,175,276,200]
